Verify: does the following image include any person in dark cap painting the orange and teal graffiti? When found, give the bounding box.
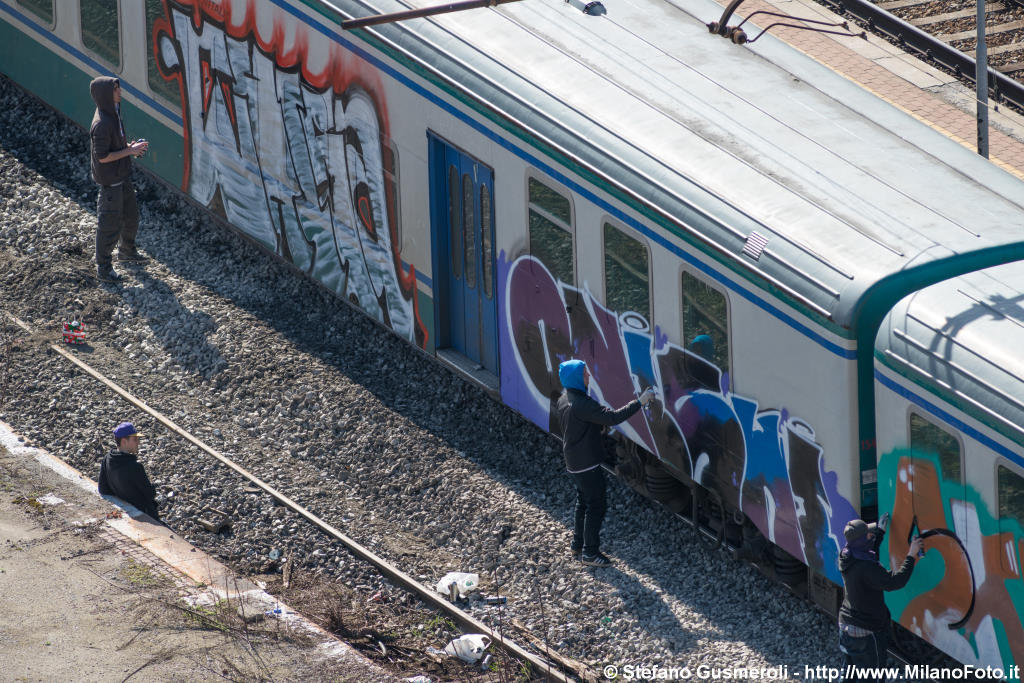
[839,513,922,681]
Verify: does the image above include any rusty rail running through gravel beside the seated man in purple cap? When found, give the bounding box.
[7,312,588,683]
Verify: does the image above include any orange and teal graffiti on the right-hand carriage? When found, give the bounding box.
[879,450,1024,670]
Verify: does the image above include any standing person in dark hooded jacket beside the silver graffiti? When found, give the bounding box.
[89,76,150,283]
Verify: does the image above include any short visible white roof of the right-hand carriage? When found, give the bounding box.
[876,263,1024,450]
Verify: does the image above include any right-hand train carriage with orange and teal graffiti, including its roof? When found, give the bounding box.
[874,263,1024,680]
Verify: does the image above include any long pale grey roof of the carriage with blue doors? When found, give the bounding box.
[321,0,1024,330]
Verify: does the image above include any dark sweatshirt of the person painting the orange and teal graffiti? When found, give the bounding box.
[839,533,915,633]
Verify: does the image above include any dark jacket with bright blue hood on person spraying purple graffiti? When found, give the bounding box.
[557,364,640,473]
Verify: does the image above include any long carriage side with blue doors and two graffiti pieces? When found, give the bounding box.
[2,0,872,581]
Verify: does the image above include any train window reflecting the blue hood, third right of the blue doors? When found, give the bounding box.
[682,270,729,373]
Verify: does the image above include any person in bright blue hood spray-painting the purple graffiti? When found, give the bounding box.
[556,360,654,567]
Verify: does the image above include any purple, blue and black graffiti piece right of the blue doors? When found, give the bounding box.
[500,256,856,582]
